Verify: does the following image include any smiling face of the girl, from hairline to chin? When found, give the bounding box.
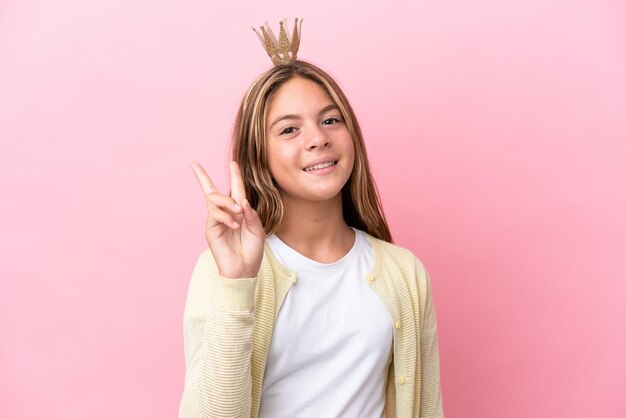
[265,77,354,202]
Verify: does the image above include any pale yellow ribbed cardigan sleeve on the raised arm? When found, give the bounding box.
[179,249,257,418]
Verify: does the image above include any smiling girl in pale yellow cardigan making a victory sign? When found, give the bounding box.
[179,19,443,418]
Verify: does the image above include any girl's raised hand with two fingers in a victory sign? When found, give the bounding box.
[191,161,265,278]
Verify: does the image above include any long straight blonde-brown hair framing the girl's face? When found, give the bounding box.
[232,60,393,242]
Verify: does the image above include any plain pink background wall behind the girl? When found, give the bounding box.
[0,0,626,418]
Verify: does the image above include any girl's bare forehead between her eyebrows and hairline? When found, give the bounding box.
[267,77,334,118]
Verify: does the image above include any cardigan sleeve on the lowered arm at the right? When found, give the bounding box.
[419,269,444,418]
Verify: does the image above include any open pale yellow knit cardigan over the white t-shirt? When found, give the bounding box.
[179,234,444,418]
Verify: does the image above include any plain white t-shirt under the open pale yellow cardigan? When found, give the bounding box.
[259,228,393,418]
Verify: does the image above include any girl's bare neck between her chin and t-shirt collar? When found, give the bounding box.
[276,194,356,263]
